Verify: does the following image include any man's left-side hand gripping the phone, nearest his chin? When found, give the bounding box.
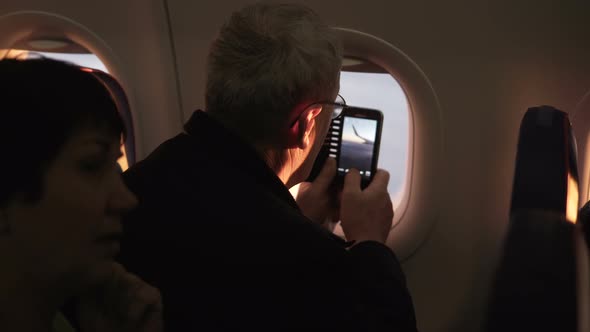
[296,158,339,230]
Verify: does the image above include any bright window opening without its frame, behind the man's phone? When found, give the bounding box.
[340,58,409,209]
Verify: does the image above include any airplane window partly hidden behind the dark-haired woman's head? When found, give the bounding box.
[0,39,134,171]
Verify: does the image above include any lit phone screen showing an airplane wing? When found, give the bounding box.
[338,116,378,180]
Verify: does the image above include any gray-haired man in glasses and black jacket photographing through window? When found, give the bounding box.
[120,4,416,332]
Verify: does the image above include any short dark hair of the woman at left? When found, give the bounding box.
[0,59,125,206]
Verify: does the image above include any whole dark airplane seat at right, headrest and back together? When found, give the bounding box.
[485,106,588,332]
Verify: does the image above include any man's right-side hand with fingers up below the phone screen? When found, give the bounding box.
[340,169,393,243]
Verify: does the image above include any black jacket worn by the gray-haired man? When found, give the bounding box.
[119,111,416,332]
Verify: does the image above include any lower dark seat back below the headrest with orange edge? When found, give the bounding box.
[486,210,578,332]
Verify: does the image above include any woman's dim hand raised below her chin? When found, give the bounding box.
[78,262,163,332]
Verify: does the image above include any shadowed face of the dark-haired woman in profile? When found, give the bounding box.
[6,130,137,289]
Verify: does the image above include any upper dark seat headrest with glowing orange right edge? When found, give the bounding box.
[510,106,578,222]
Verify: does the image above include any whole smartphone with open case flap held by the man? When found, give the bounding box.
[307,106,383,189]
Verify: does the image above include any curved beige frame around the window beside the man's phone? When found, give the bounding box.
[334,27,444,262]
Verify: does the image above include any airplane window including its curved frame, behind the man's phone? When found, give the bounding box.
[334,27,444,261]
